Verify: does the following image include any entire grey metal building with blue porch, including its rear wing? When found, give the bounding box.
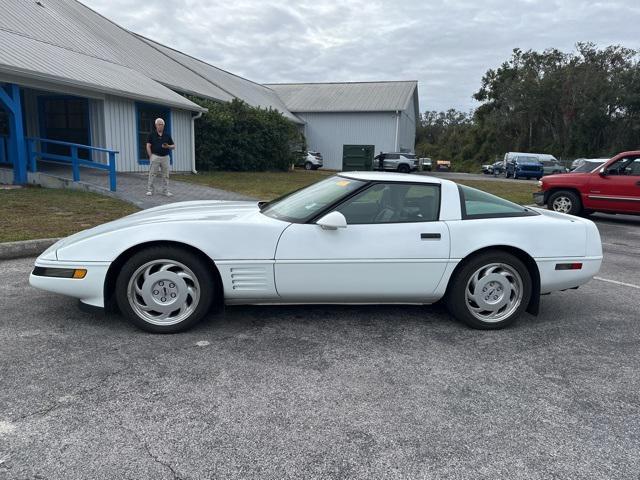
[0,0,418,188]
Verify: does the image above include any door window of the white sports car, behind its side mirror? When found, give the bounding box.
[336,183,440,225]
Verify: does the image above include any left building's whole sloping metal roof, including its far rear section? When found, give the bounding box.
[0,0,302,116]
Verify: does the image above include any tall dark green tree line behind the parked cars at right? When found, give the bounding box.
[416,43,640,170]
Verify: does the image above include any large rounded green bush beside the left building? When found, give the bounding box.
[190,97,305,171]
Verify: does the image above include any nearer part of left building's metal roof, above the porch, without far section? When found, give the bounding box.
[0,0,225,110]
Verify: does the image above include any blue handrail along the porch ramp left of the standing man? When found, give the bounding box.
[27,137,120,192]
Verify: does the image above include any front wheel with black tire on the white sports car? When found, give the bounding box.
[115,247,217,333]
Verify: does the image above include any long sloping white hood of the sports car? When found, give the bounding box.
[45,200,259,253]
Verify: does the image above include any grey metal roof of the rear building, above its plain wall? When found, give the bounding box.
[267,80,418,113]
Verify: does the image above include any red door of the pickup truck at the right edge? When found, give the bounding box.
[587,155,640,213]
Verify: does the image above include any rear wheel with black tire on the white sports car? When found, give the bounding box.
[445,251,532,330]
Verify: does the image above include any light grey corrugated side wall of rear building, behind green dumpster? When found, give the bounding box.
[296,112,398,170]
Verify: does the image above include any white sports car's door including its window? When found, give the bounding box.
[275,183,450,302]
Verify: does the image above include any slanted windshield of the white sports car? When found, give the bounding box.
[262,175,366,223]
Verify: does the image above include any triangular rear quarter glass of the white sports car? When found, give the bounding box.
[458,185,538,220]
